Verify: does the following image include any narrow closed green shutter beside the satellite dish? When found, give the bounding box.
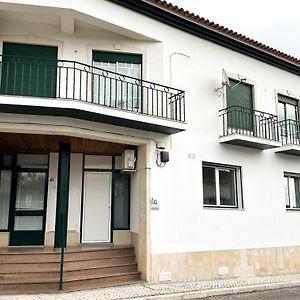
[226,79,253,131]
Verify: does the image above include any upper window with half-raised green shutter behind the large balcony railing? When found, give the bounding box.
[93,51,142,110]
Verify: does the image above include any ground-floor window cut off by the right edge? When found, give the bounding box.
[284,173,300,209]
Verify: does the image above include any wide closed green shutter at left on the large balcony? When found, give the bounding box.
[0,43,57,97]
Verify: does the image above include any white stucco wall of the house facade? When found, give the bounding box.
[0,0,300,253]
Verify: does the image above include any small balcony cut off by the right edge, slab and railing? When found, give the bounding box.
[276,119,300,156]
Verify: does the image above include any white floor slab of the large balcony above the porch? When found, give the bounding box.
[0,95,186,134]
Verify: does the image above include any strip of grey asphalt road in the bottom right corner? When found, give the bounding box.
[207,287,300,300]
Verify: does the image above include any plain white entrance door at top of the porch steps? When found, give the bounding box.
[82,172,111,243]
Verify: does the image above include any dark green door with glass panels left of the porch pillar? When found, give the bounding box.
[10,171,47,245]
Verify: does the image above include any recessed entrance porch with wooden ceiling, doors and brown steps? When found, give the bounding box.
[0,132,147,292]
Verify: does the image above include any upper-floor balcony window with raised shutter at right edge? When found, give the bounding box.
[278,94,300,144]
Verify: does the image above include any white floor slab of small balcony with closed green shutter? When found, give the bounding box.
[219,134,281,150]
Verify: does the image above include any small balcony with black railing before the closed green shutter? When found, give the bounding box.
[219,106,281,150]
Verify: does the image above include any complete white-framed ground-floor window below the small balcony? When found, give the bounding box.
[202,163,242,208]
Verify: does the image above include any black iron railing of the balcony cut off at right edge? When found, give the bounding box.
[279,119,300,146]
